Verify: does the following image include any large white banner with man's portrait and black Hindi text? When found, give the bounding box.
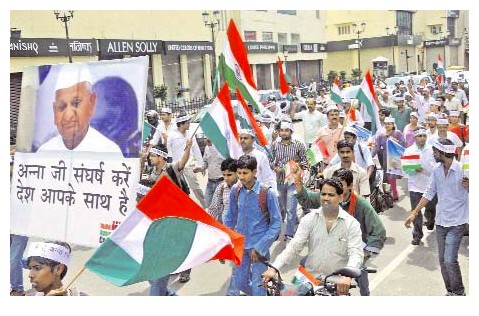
[10,56,148,247]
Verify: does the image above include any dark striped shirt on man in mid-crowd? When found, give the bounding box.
[270,140,308,184]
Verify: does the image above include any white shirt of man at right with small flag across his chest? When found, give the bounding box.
[403,143,437,193]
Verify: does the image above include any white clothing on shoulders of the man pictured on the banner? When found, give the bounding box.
[37,126,122,154]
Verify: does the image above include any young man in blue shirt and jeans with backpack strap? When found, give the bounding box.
[224,155,281,296]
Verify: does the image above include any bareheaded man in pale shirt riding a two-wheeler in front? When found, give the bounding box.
[263,178,364,295]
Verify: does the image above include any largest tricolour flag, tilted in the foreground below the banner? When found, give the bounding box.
[85,176,244,286]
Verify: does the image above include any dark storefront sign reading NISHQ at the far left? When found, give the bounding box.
[10,38,98,57]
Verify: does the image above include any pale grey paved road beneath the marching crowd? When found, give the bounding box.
[18,124,469,296]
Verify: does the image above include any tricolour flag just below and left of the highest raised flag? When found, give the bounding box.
[200,83,243,159]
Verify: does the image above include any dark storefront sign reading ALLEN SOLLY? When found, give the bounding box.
[98,39,163,56]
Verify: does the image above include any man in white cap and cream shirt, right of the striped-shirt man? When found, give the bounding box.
[315,104,344,168]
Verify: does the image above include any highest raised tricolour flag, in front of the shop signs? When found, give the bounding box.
[220,19,264,113]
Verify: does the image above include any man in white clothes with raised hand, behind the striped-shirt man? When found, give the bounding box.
[289,97,328,148]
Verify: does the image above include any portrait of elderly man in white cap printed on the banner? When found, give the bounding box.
[38,63,121,153]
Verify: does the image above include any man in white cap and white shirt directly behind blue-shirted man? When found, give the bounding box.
[239,129,278,195]
